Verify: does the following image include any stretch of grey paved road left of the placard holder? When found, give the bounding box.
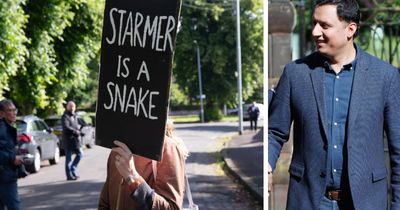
[18,146,110,210]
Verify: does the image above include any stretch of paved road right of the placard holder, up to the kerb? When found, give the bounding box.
[176,123,262,210]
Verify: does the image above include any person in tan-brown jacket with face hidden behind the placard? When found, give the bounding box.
[98,120,188,210]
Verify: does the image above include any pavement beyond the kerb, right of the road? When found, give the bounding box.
[221,127,264,203]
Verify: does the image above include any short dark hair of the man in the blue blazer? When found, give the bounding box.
[315,0,361,37]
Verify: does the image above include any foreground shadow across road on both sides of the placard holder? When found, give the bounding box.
[19,174,261,210]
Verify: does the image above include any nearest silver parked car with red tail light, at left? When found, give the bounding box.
[16,115,60,173]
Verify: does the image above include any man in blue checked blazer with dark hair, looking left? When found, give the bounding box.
[268,0,400,210]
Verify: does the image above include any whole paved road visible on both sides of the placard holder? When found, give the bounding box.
[18,123,261,210]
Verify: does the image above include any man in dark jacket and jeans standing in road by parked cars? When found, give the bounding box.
[61,101,83,180]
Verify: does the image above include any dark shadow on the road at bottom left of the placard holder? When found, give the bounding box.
[18,181,104,210]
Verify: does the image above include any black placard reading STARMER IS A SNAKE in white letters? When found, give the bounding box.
[96,0,181,160]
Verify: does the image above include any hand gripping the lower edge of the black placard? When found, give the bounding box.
[112,141,139,179]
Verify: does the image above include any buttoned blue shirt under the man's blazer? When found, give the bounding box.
[324,57,357,189]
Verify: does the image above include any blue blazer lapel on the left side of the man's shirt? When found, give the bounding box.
[310,67,327,143]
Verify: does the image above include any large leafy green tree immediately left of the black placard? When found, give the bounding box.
[3,0,104,114]
